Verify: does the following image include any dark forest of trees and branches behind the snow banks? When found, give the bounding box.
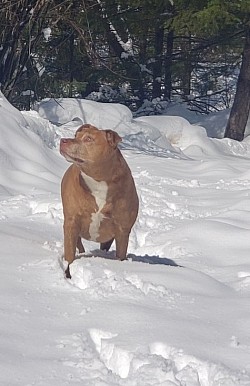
[0,0,250,140]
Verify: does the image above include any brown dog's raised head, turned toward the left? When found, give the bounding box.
[60,125,122,166]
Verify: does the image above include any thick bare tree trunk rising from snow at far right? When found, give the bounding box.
[225,28,250,141]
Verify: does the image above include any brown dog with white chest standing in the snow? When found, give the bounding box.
[60,125,138,278]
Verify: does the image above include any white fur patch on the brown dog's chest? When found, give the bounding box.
[81,172,108,241]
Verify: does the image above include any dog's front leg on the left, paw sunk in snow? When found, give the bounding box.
[63,218,79,279]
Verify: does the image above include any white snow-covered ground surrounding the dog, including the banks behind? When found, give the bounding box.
[0,96,250,386]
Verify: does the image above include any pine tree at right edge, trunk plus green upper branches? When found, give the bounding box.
[173,0,250,140]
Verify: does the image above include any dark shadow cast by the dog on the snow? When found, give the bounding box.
[81,249,181,267]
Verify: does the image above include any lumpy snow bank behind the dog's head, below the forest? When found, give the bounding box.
[37,98,249,159]
